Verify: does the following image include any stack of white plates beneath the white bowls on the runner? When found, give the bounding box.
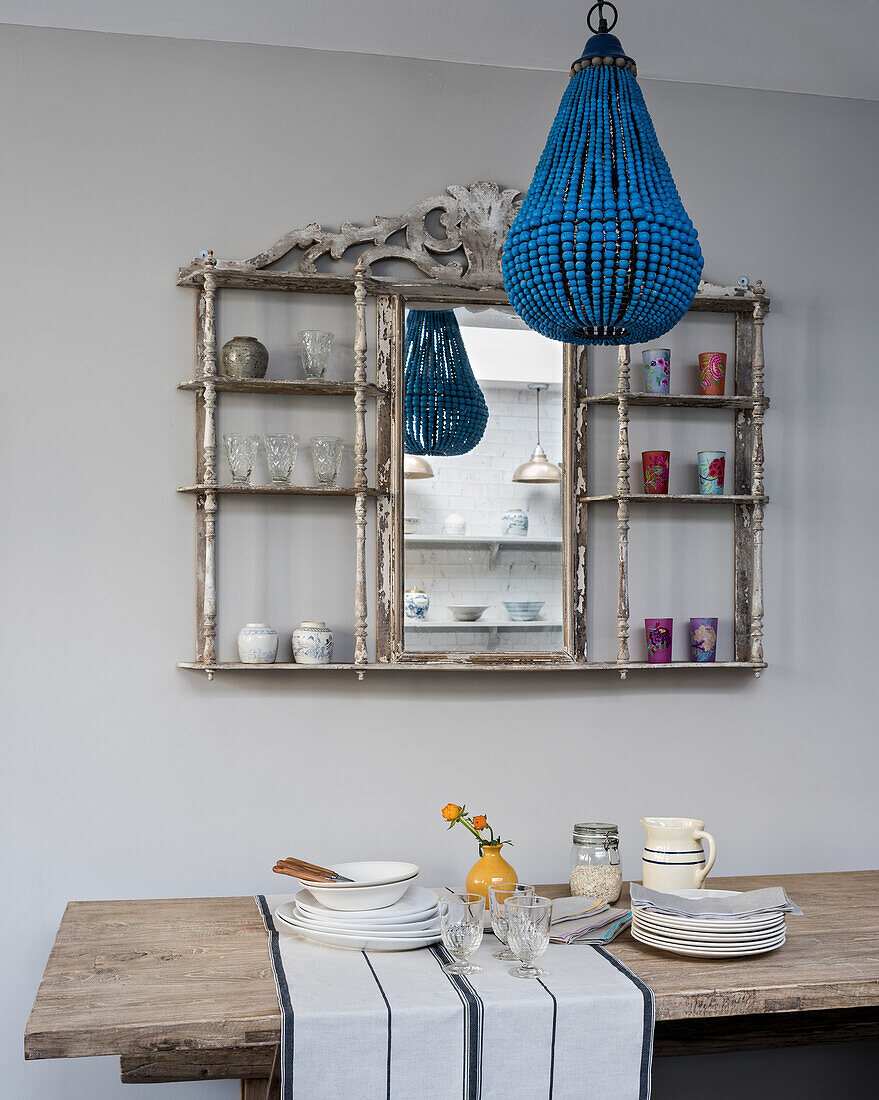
[275,886,440,952]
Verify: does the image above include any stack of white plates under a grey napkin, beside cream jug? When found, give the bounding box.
[631,890,787,959]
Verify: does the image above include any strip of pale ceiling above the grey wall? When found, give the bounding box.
[0,0,879,99]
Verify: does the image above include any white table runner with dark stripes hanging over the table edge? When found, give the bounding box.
[256,894,653,1100]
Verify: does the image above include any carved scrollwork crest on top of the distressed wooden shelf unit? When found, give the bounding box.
[180,180,523,287]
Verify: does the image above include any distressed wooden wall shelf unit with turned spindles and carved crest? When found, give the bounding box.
[177,182,769,680]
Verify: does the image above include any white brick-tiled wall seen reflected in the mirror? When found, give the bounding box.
[404,382,562,652]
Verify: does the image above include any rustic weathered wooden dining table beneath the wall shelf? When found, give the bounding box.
[24,870,879,1100]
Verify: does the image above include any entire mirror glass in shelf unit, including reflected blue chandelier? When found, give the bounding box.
[403,306,563,653]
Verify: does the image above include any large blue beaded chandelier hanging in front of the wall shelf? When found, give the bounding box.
[502,2,702,344]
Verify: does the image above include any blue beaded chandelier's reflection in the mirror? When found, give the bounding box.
[404,309,488,454]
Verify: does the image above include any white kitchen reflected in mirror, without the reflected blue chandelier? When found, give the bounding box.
[400,303,564,655]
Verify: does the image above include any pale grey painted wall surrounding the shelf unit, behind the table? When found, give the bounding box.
[0,21,879,1100]
